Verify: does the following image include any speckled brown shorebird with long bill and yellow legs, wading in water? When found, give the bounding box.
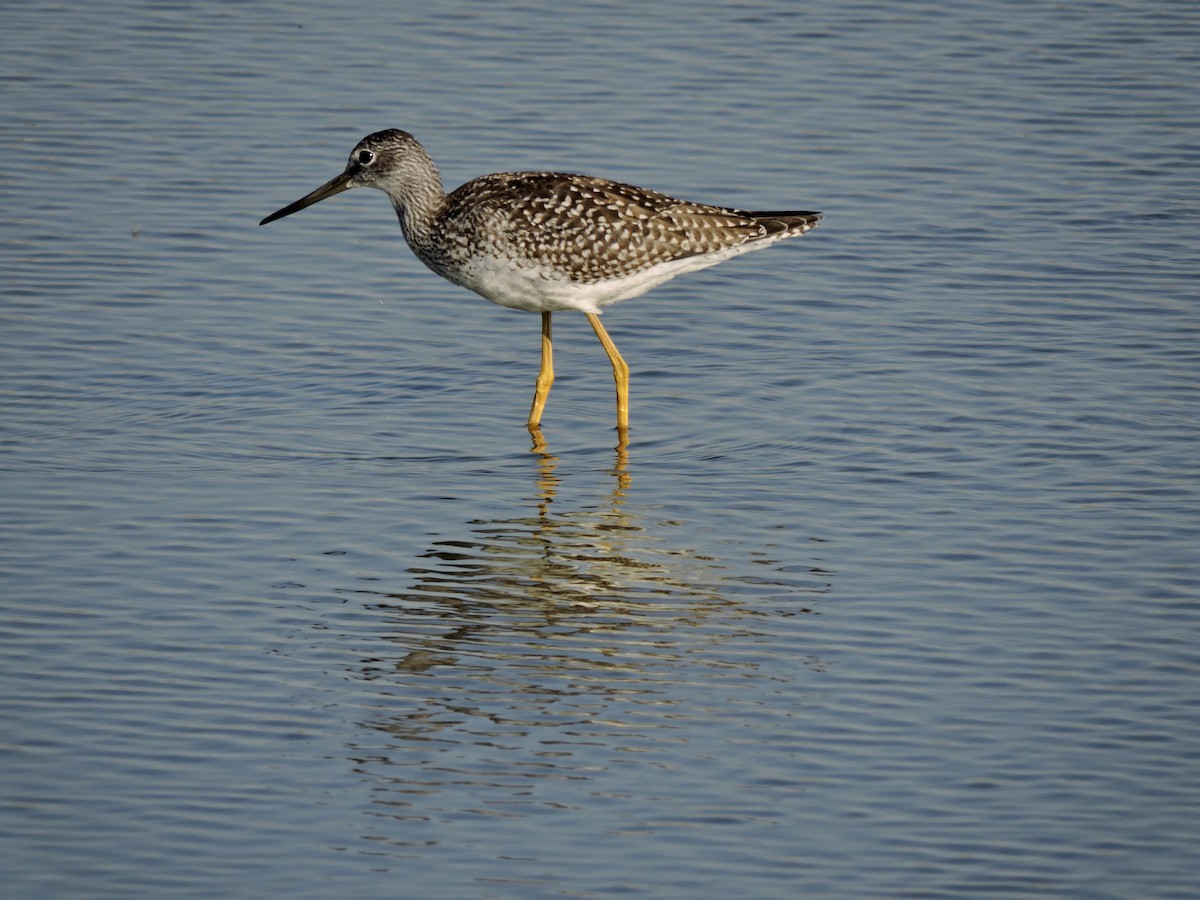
[259,128,821,445]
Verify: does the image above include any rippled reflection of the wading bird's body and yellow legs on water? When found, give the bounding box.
[358,444,828,705]
